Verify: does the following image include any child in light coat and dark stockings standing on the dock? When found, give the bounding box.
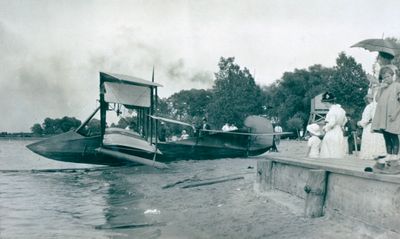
[372,65,400,169]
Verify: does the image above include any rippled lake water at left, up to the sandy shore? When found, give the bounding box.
[0,140,166,238]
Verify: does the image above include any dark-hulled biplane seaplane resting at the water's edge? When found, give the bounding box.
[27,72,287,168]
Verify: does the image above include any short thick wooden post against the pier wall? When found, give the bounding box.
[304,169,326,217]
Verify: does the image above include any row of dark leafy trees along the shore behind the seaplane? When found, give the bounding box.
[31,41,400,135]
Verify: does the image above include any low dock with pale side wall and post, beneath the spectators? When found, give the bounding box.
[257,154,400,232]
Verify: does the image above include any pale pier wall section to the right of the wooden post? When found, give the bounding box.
[325,173,400,231]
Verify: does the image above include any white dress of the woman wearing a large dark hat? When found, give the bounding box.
[320,104,347,158]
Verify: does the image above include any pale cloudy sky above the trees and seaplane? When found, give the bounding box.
[0,0,400,132]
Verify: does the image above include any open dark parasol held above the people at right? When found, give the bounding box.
[351,39,400,56]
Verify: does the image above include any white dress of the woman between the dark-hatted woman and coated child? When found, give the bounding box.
[358,101,386,159]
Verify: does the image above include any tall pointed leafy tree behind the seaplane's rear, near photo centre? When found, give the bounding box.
[207,57,265,127]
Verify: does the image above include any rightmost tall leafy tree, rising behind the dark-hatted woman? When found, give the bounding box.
[328,52,369,119]
